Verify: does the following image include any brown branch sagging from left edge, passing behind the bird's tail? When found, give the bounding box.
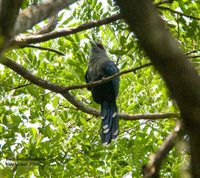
[0,58,179,120]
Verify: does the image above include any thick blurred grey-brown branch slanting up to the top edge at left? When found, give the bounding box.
[14,0,76,35]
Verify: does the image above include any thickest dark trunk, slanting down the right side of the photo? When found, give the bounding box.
[117,0,200,178]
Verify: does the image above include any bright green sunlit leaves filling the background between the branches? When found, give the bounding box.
[0,0,200,177]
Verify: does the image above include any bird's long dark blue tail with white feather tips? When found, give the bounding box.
[101,102,119,145]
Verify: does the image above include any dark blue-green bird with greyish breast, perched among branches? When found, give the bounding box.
[85,41,120,145]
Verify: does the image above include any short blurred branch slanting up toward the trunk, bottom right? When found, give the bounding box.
[142,121,181,178]
